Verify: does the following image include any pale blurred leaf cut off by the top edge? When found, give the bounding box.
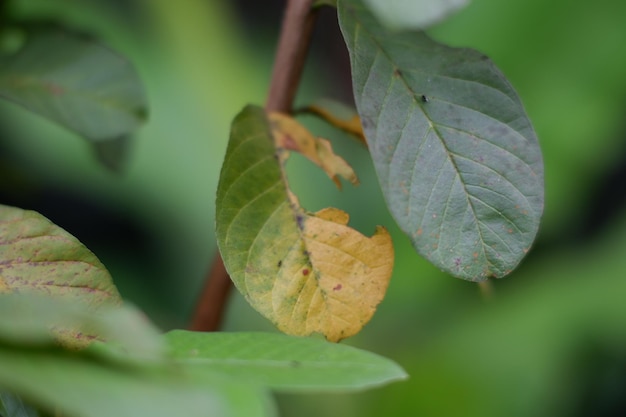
[356,0,469,30]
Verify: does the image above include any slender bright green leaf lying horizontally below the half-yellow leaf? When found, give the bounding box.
[165,330,407,392]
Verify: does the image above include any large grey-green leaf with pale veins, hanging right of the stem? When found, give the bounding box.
[339,0,543,281]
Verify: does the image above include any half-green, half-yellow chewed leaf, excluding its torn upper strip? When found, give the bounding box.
[216,106,393,341]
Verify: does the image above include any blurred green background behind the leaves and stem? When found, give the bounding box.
[0,0,626,417]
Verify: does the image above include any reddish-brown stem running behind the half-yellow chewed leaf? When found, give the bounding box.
[189,0,317,332]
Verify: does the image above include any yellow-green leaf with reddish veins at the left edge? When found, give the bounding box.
[0,205,121,346]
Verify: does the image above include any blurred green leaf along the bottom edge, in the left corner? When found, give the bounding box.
[0,346,227,417]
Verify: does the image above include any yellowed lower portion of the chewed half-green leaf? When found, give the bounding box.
[272,208,394,342]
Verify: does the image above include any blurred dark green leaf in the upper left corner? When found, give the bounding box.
[0,30,147,142]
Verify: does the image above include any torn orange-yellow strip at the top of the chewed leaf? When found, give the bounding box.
[269,112,359,189]
